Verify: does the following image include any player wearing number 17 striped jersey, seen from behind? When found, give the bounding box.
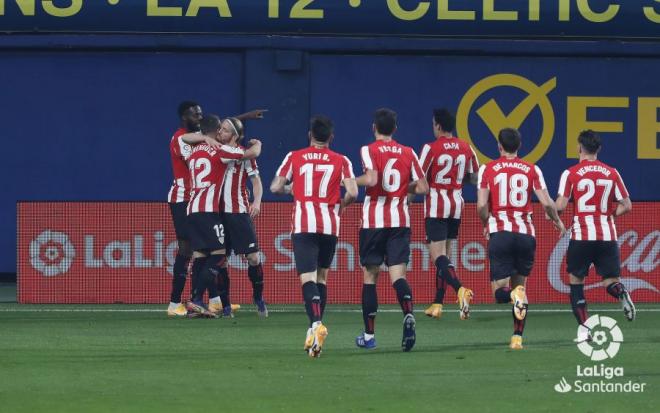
[270,115,358,357]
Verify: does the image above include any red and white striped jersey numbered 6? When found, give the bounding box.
[360,140,424,228]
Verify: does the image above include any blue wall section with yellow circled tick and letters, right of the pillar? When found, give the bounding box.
[311,55,660,200]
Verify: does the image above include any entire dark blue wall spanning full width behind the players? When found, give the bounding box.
[0,50,660,272]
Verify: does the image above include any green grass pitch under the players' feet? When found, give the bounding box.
[0,304,660,413]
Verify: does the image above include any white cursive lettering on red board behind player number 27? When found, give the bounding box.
[547,230,660,294]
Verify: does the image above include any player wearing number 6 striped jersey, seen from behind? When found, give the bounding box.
[355,109,429,351]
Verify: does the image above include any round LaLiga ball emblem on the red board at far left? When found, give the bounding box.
[30,230,76,277]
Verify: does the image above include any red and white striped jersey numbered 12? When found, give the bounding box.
[188,143,244,215]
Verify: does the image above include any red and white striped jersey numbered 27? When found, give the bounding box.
[559,159,629,241]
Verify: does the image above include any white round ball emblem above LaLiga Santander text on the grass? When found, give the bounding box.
[577,314,623,361]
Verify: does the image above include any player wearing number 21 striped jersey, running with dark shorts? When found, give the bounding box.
[418,109,479,320]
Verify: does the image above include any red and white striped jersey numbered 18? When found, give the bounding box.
[477,157,546,236]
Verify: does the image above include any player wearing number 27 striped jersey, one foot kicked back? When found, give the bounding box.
[556,130,635,334]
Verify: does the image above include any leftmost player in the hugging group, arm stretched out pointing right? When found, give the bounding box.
[167,100,266,316]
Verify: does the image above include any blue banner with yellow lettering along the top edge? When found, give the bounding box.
[0,0,660,38]
